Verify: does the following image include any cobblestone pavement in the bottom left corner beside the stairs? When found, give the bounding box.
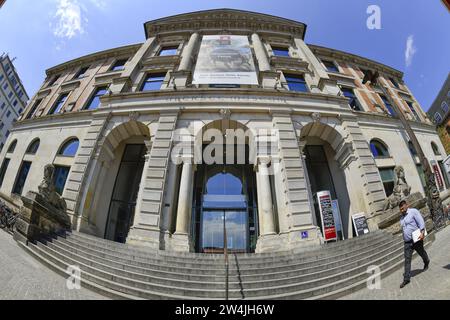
[0,230,106,301]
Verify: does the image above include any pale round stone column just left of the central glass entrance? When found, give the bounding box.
[172,157,194,252]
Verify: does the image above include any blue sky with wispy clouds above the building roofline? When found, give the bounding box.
[0,0,450,110]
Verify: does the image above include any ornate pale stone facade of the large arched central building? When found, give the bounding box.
[0,9,447,253]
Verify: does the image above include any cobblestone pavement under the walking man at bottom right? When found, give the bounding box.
[342,226,450,300]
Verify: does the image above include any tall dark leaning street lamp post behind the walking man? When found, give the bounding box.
[363,70,446,230]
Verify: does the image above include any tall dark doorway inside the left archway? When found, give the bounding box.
[105,144,147,243]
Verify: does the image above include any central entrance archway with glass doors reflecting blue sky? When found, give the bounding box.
[192,120,258,254]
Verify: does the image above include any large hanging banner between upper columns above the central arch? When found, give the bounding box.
[192,35,259,85]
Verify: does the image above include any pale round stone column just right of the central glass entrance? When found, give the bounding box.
[257,157,275,236]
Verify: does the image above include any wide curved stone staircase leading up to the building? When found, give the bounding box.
[16,231,432,300]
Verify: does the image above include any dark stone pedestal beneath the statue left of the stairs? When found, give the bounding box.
[14,192,71,244]
